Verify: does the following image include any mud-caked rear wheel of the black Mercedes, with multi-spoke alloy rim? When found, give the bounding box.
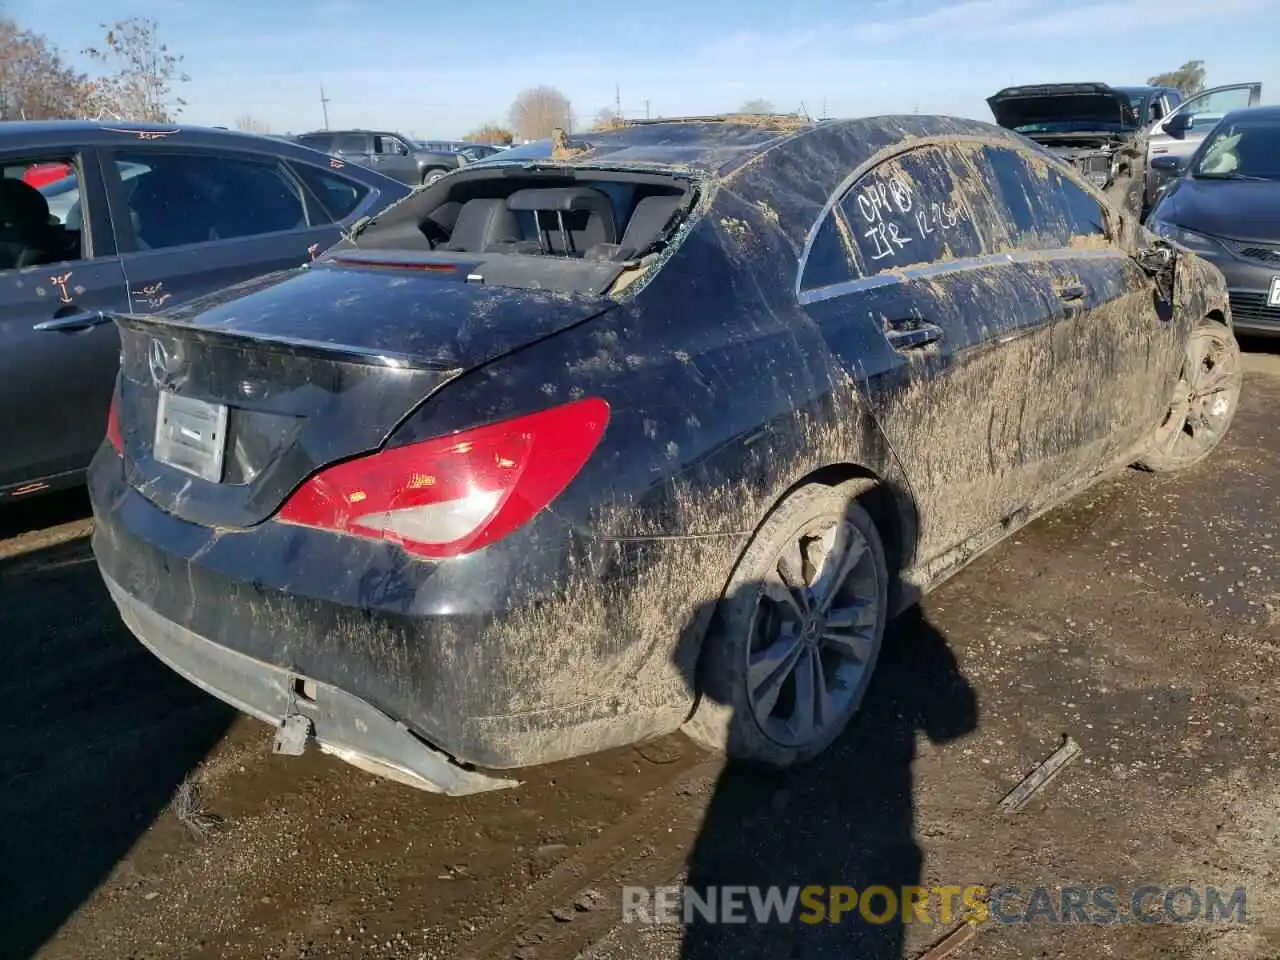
[685,481,888,767]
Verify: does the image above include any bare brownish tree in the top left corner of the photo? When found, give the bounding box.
[0,18,90,120]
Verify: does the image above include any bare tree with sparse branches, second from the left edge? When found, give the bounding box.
[84,17,191,123]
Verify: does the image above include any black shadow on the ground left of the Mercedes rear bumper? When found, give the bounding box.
[0,506,234,957]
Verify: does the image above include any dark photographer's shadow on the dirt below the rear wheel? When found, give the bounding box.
[681,607,978,960]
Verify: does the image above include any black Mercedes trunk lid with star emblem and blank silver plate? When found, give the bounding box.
[111,255,613,527]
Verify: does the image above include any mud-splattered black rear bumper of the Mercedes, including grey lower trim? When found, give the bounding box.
[90,444,701,786]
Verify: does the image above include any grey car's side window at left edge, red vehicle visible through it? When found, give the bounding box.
[0,156,90,270]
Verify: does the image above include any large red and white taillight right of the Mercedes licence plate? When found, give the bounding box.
[279,397,609,557]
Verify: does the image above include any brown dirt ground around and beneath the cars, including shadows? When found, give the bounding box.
[0,353,1280,960]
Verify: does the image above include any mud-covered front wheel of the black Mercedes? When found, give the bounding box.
[1138,320,1242,474]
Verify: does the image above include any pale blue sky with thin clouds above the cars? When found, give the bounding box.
[5,0,1280,137]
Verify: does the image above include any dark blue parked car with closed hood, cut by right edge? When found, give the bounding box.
[1148,106,1280,335]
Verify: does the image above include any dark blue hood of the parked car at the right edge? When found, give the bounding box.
[1155,177,1280,243]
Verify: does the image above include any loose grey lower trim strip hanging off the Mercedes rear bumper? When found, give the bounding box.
[102,575,518,796]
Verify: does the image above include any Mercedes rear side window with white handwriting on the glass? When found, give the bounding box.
[840,146,986,276]
